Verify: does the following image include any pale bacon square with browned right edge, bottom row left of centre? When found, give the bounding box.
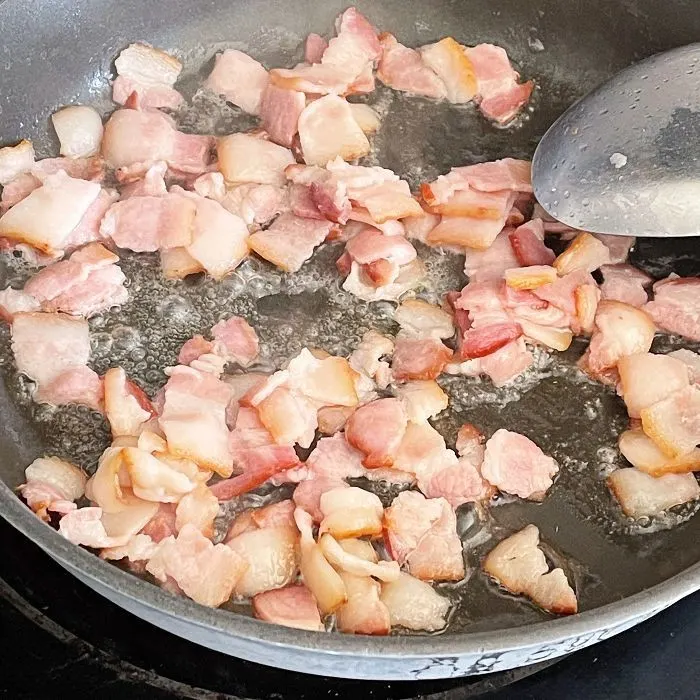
[226,526,298,598]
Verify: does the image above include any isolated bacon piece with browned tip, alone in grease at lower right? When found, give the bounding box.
[482,525,578,615]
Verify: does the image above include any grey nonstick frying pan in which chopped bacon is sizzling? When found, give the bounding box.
[0,0,700,679]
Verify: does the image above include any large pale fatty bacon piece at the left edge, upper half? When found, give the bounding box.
[0,172,101,256]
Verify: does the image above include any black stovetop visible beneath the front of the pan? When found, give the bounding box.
[0,518,700,700]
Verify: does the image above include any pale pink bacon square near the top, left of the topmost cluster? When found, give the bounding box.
[204,49,268,114]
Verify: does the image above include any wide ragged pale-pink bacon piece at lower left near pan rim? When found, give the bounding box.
[146,525,247,607]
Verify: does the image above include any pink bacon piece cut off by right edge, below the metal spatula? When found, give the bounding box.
[644,276,700,340]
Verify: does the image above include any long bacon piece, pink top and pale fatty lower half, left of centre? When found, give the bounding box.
[159,366,233,477]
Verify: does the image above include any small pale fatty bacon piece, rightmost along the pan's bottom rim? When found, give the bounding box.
[380,573,451,632]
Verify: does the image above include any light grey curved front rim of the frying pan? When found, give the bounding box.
[0,482,700,659]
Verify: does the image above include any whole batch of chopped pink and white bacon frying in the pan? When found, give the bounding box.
[0,8,700,634]
